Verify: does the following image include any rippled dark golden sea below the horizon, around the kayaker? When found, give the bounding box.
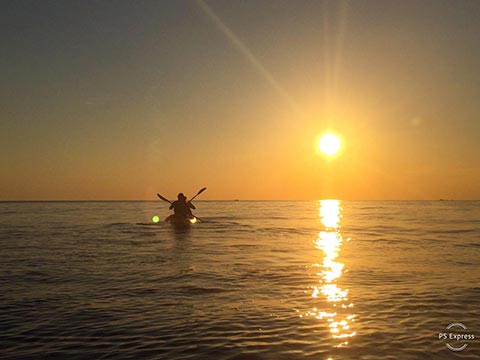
[0,201,480,360]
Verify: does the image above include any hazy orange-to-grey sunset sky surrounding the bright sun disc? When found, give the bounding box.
[0,0,480,200]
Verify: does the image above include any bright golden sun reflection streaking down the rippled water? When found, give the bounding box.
[306,200,355,347]
